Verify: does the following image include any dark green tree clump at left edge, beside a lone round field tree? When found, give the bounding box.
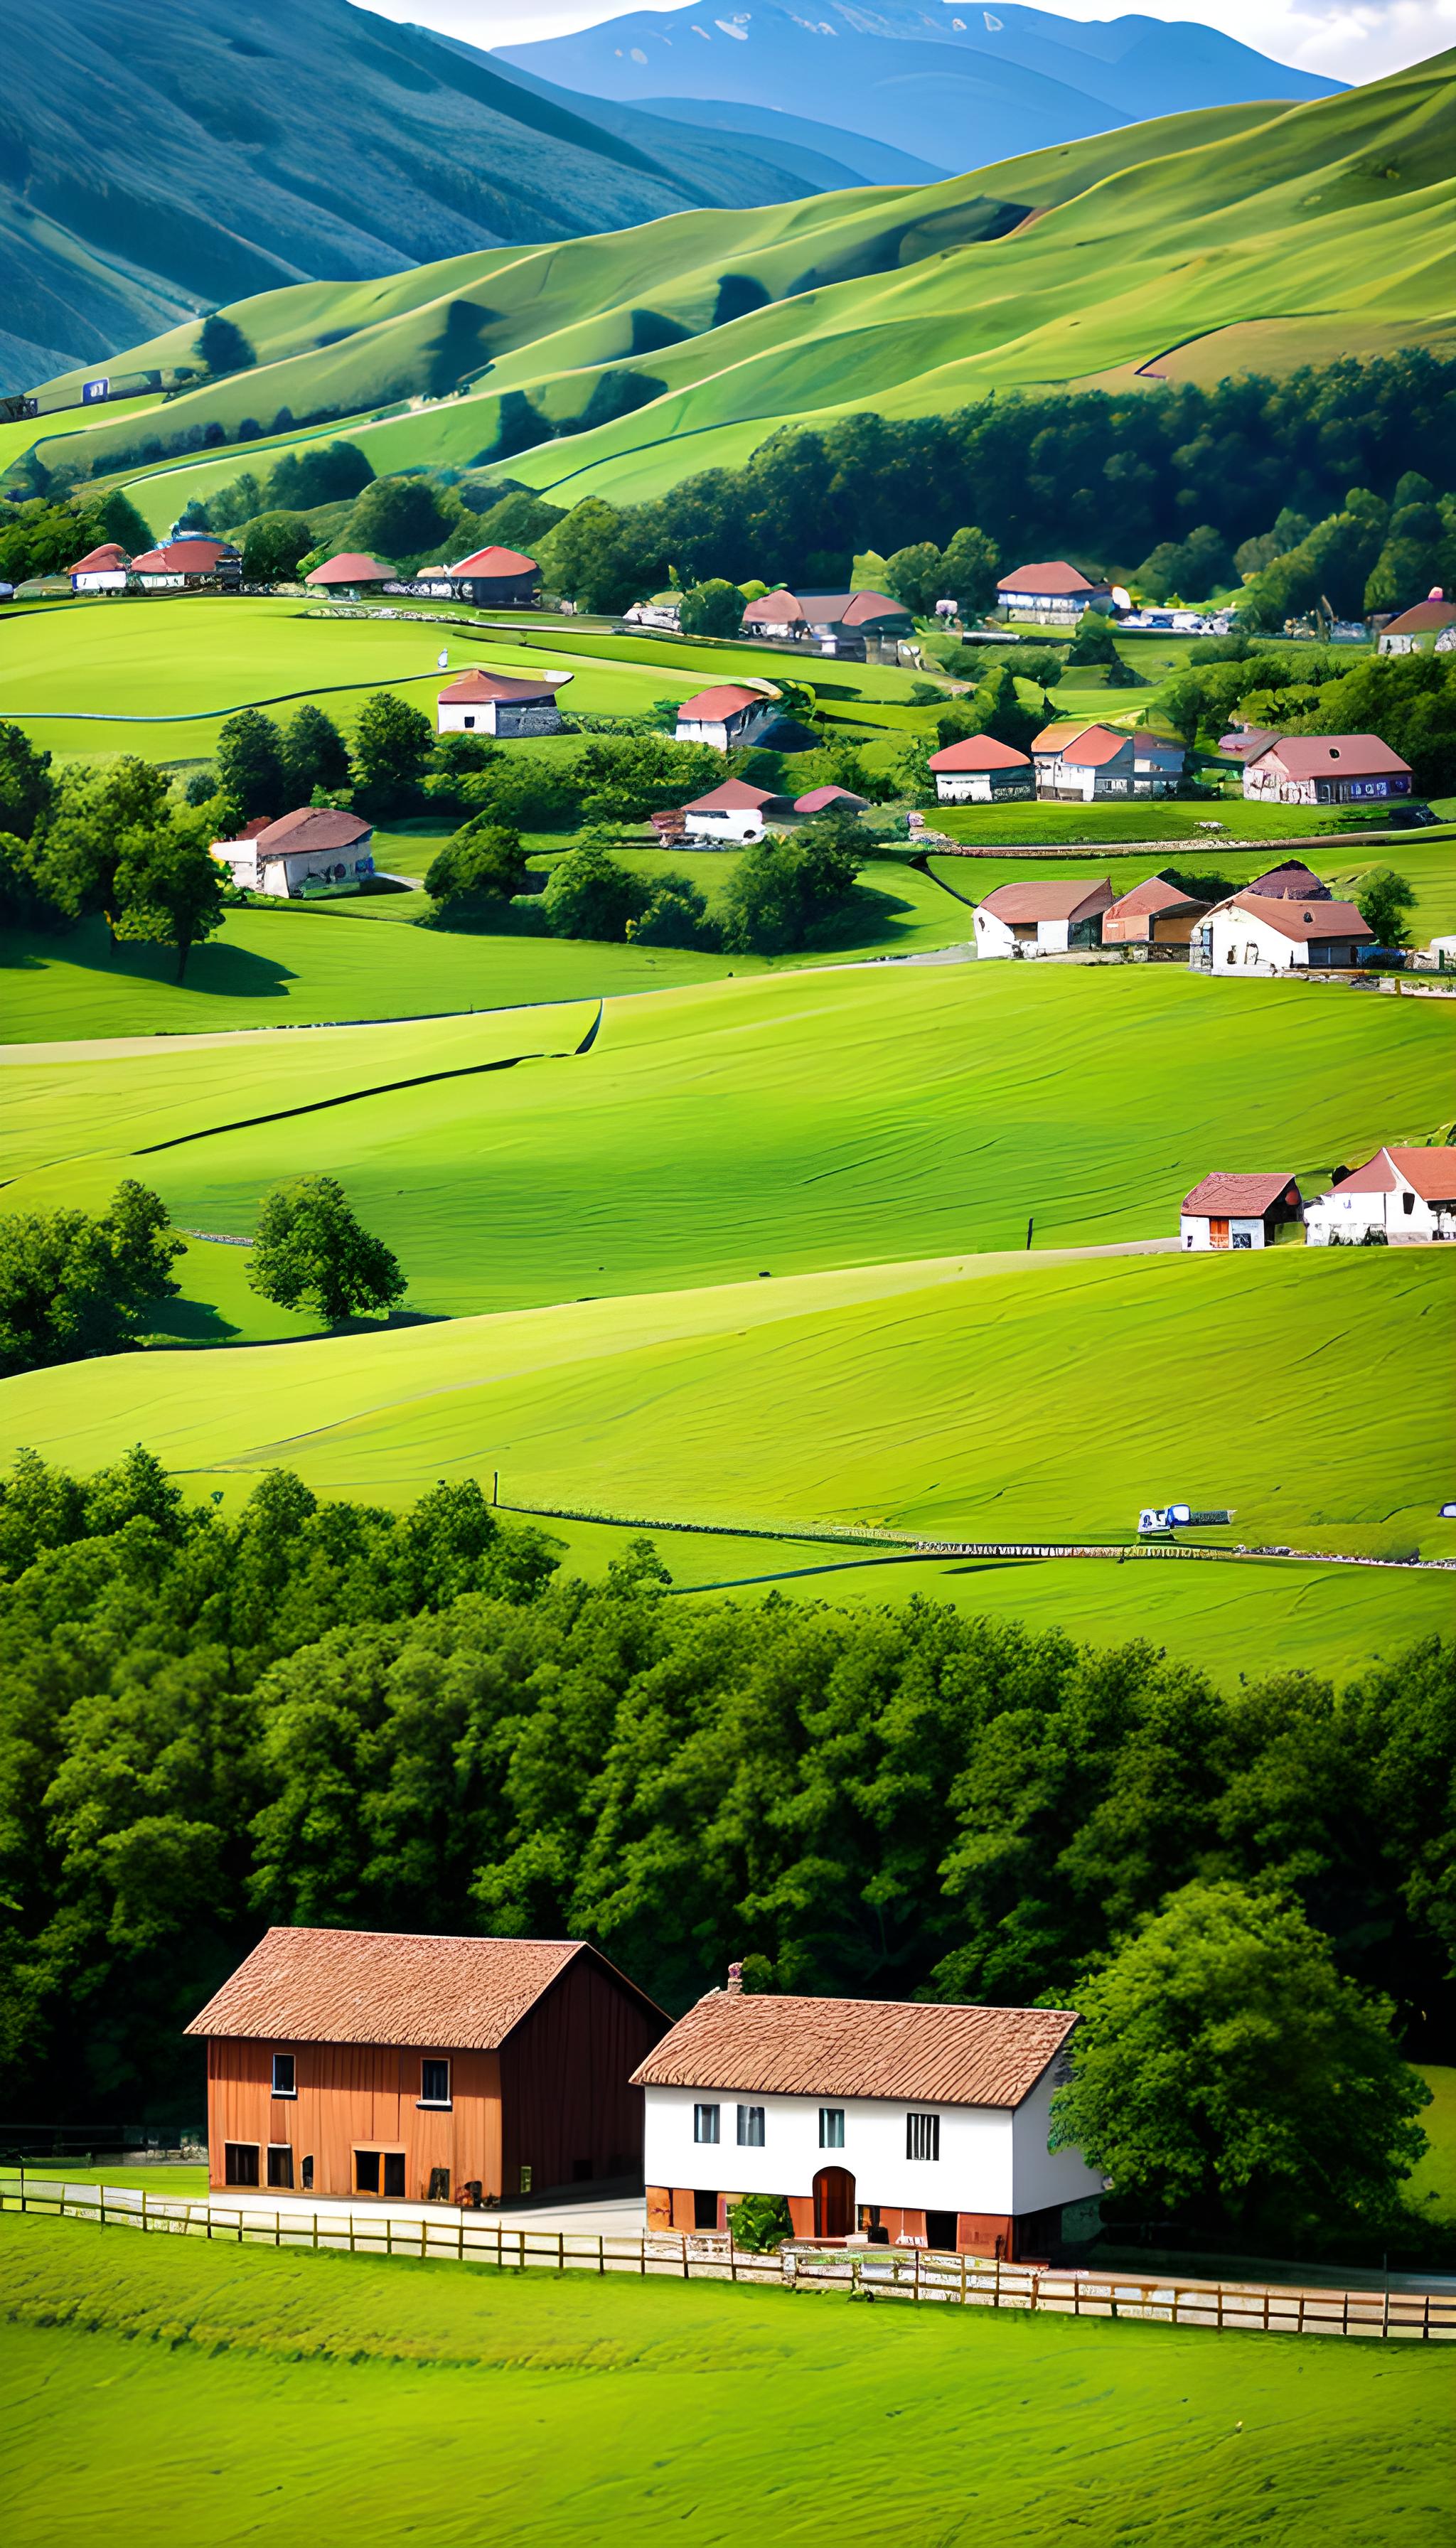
[0,1177,183,1374]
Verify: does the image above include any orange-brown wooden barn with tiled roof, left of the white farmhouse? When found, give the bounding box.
[186,1929,668,2202]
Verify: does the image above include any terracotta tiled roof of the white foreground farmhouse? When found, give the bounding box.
[632,1990,1076,2107]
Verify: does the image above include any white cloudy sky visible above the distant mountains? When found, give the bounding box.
[382,0,1456,82]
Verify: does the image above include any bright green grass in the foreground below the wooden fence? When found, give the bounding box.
[0,2217,1451,2548]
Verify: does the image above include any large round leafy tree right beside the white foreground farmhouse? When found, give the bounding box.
[1053,1883,1430,2234]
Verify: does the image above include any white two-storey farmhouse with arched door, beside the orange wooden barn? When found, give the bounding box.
[632,1967,1101,2257]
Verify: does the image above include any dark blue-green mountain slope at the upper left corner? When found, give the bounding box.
[0,0,913,390]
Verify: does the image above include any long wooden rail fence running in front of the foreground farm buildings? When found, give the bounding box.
[0,2176,1456,2344]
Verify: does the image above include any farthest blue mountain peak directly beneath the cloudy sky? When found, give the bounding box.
[495,0,1342,171]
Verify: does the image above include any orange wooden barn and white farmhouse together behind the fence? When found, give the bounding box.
[186,1929,1104,2260]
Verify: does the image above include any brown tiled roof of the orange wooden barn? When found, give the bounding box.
[183,1929,653,2051]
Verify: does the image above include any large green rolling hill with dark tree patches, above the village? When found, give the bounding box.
[41,53,1456,520]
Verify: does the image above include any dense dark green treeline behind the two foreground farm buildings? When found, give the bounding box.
[0,1452,1456,2115]
